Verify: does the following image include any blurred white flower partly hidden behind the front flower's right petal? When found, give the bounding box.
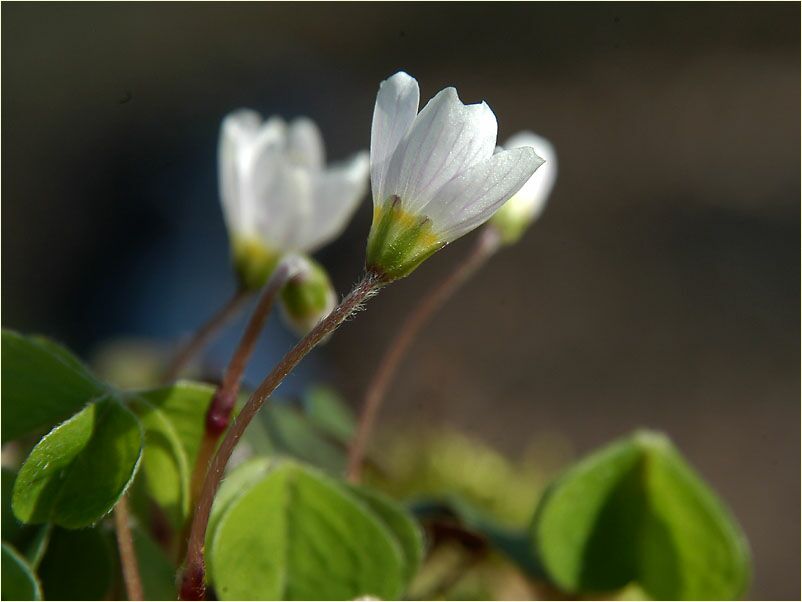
[490,132,557,244]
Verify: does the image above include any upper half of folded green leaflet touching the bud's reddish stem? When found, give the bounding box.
[133,381,215,470]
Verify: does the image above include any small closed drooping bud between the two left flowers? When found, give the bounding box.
[281,256,337,336]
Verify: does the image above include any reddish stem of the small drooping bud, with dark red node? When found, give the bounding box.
[190,259,298,506]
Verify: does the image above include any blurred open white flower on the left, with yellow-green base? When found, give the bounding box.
[219,109,369,288]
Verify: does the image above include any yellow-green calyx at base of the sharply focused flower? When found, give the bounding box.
[365,196,445,282]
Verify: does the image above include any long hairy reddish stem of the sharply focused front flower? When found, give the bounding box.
[180,274,383,600]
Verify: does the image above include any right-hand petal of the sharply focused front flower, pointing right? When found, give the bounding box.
[425,147,543,242]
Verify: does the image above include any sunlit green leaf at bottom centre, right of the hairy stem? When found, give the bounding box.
[209,462,405,600]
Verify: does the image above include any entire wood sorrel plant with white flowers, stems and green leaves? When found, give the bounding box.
[1,72,750,600]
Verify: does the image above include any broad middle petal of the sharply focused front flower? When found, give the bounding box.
[386,88,497,213]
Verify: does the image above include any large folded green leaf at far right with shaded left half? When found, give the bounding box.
[532,432,750,600]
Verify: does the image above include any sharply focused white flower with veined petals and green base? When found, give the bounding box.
[367,72,543,280]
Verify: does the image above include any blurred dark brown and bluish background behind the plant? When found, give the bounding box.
[2,3,800,599]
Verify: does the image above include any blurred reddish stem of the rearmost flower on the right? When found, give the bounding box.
[346,226,501,483]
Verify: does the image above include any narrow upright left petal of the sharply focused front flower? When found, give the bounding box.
[370,71,420,203]
